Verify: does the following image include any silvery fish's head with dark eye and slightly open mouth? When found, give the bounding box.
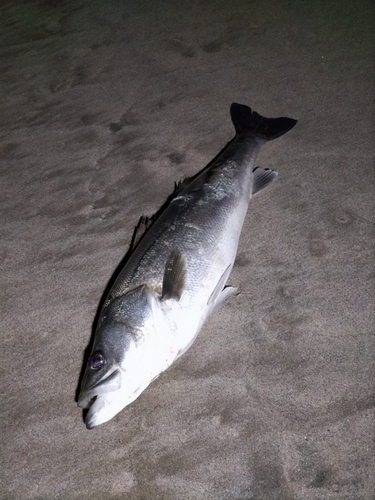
[78,286,169,429]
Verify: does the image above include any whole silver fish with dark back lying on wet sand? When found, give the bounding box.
[77,103,297,429]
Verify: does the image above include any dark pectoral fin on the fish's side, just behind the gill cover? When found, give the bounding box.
[161,249,186,300]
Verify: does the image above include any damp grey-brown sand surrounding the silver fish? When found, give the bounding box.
[0,0,375,500]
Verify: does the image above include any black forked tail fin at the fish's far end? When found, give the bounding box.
[230,102,297,141]
